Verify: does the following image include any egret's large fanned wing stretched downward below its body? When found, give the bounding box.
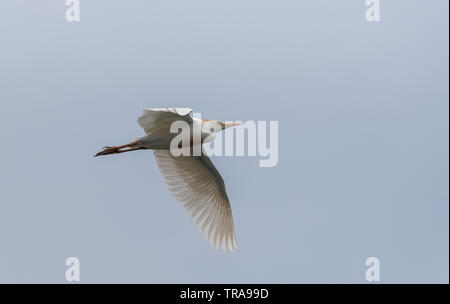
[153,150,237,251]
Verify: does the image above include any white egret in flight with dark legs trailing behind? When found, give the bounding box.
[95,108,238,251]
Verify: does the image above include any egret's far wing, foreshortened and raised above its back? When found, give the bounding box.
[138,108,192,134]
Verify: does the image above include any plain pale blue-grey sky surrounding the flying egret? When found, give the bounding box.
[0,0,449,283]
